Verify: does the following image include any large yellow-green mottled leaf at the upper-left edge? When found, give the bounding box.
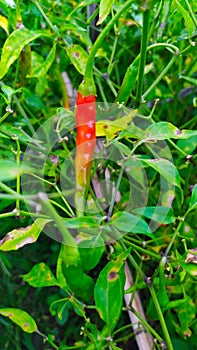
[0,28,47,79]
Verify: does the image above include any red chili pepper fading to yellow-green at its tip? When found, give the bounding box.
[75,92,96,215]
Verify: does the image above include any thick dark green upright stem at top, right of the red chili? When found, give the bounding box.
[136,9,150,106]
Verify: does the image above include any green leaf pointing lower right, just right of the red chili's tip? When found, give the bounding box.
[109,211,154,239]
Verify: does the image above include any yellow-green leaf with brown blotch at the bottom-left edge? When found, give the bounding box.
[0,308,38,333]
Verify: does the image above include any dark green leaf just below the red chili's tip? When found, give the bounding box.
[78,235,104,271]
